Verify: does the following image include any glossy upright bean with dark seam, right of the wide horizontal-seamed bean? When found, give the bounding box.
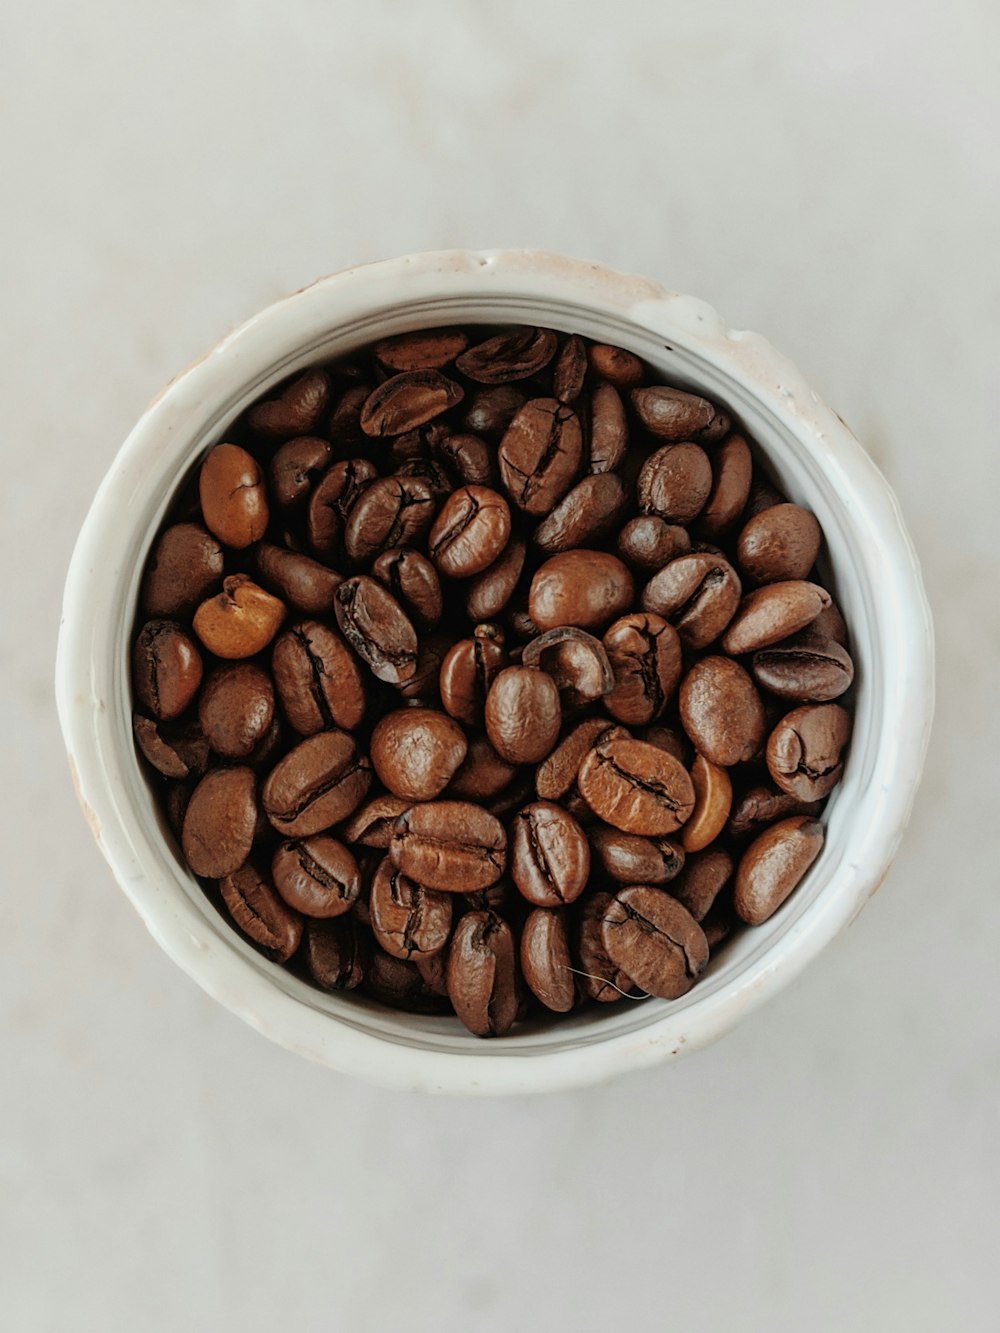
[511,801,591,908]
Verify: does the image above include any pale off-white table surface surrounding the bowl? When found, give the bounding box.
[0,0,1000,1333]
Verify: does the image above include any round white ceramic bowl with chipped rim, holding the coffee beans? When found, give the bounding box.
[57,252,933,1093]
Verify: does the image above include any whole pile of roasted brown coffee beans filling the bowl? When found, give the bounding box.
[132,327,853,1037]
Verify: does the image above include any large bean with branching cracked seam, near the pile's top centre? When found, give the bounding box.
[497,399,583,517]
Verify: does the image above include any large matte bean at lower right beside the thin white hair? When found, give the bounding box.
[601,884,708,1000]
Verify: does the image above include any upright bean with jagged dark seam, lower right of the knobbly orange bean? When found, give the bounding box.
[271,620,365,736]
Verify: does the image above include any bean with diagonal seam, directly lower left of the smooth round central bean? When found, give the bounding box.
[260,730,372,837]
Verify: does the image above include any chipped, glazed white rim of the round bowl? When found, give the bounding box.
[56,251,933,1093]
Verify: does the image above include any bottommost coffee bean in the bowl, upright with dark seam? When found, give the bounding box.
[448,912,517,1037]
